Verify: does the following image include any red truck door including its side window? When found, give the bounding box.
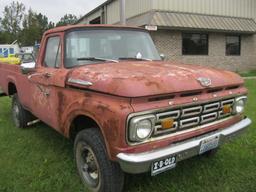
[29,35,68,130]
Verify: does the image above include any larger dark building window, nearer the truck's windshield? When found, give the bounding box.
[182,33,208,55]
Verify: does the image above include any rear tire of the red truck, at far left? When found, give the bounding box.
[12,93,34,128]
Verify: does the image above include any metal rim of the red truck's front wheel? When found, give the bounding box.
[77,143,100,189]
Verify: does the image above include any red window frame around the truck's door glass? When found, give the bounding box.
[42,34,63,69]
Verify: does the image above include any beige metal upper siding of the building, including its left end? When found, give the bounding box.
[81,0,256,24]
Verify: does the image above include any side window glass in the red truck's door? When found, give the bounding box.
[44,37,61,68]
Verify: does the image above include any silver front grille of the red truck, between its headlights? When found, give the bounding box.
[154,98,235,137]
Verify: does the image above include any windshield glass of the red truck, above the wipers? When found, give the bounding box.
[65,29,161,68]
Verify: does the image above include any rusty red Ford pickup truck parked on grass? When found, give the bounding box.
[0,25,251,192]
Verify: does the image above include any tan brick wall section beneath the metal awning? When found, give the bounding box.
[151,30,256,71]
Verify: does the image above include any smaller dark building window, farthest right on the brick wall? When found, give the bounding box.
[226,35,241,56]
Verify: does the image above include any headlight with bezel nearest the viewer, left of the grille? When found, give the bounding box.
[129,115,155,142]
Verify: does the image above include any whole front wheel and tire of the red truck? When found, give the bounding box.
[74,128,124,192]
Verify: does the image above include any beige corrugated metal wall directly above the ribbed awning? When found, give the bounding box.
[152,0,256,18]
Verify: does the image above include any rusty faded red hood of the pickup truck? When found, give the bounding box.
[67,61,243,97]
